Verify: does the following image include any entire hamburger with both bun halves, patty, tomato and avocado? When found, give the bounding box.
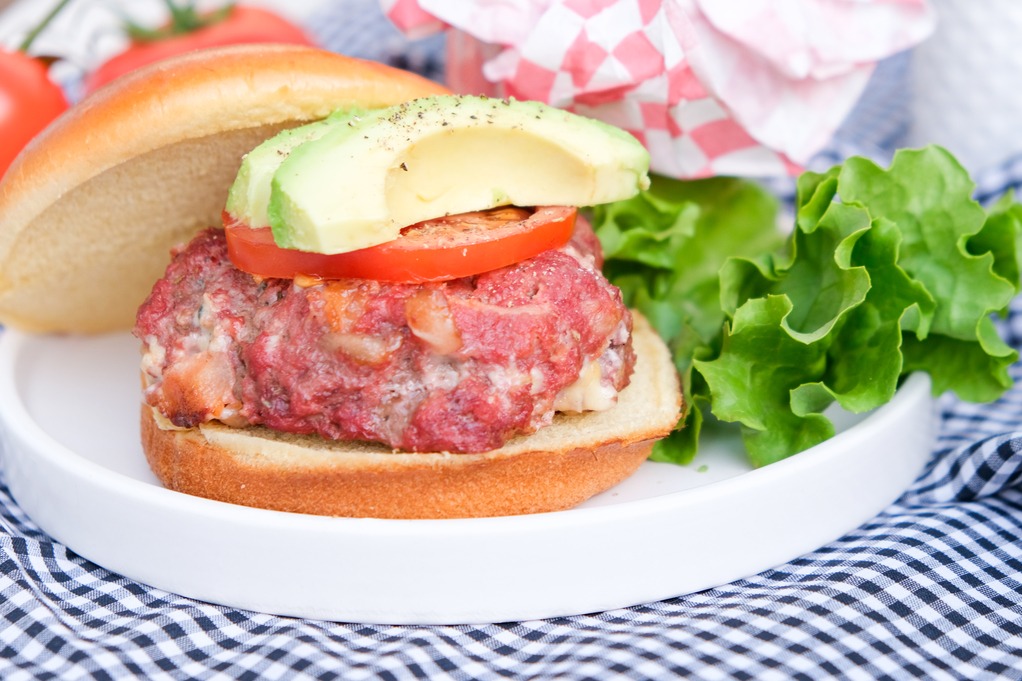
[0,46,681,518]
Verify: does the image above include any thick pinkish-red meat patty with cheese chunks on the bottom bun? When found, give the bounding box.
[135,220,635,452]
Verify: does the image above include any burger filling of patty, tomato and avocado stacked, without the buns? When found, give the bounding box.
[135,91,648,452]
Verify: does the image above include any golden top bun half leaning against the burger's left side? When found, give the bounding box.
[0,45,446,332]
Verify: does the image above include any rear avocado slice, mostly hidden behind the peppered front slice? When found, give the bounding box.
[225,107,366,227]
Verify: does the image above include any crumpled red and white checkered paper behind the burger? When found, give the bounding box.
[381,0,935,178]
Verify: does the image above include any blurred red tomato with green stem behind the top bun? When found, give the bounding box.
[85,0,314,93]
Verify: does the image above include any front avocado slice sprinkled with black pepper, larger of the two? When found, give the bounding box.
[268,95,649,254]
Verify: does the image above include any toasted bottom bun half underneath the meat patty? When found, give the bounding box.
[142,316,681,518]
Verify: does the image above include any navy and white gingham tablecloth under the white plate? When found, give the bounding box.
[0,0,1022,681]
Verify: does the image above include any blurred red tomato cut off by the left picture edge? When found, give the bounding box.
[0,51,67,176]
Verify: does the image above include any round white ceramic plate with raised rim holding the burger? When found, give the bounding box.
[0,330,935,624]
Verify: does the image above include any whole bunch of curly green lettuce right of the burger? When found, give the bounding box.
[593,146,1022,466]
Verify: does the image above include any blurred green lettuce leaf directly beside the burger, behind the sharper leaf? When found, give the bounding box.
[593,177,783,463]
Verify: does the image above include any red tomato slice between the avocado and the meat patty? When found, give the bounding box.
[224,206,578,283]
